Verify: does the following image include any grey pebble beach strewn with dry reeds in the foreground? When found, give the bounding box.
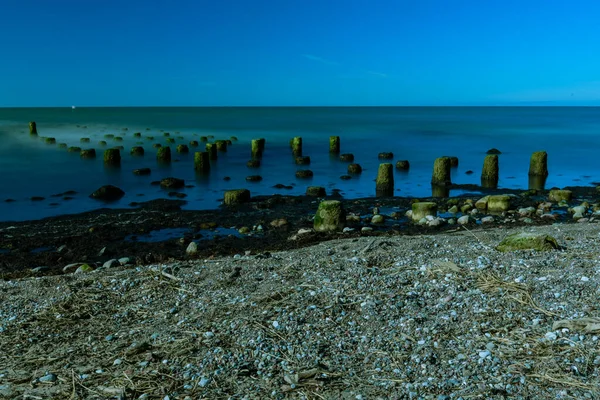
[0,223,600,399]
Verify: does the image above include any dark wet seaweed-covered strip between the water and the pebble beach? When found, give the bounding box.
[0,187,597,279]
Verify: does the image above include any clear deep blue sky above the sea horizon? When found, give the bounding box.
[0,0,600,107]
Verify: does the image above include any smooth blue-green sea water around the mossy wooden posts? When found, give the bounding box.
[0,107,600,221]
